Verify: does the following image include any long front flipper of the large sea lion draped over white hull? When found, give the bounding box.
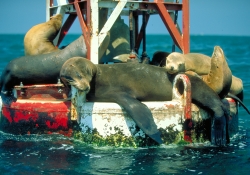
[109,93,163,144]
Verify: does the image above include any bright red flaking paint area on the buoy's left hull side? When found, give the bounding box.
[2,100,70,126]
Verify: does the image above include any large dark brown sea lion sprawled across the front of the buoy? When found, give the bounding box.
[60,57,228,144]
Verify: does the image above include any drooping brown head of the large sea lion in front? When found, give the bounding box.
[60,57,97,93]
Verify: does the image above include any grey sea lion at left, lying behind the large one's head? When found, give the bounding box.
[0,35,87,105]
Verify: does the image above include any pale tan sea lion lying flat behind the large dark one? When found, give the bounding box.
[165,52,211,75]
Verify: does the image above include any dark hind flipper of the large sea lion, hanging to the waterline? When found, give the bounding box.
[211,116,227,146]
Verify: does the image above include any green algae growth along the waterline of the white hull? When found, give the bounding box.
[73,125,195,148]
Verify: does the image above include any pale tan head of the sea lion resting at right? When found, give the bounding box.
[165,52,185,74]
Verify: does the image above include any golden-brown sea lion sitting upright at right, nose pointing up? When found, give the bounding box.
[202,46,232,98]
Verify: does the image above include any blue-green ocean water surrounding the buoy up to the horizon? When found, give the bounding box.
[0,35,250,175]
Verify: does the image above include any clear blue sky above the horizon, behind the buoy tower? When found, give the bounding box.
[0,0,250,36]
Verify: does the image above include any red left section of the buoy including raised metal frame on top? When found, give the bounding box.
[1,84,72,136]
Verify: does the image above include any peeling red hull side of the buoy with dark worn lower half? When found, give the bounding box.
[2,100,71,134]
